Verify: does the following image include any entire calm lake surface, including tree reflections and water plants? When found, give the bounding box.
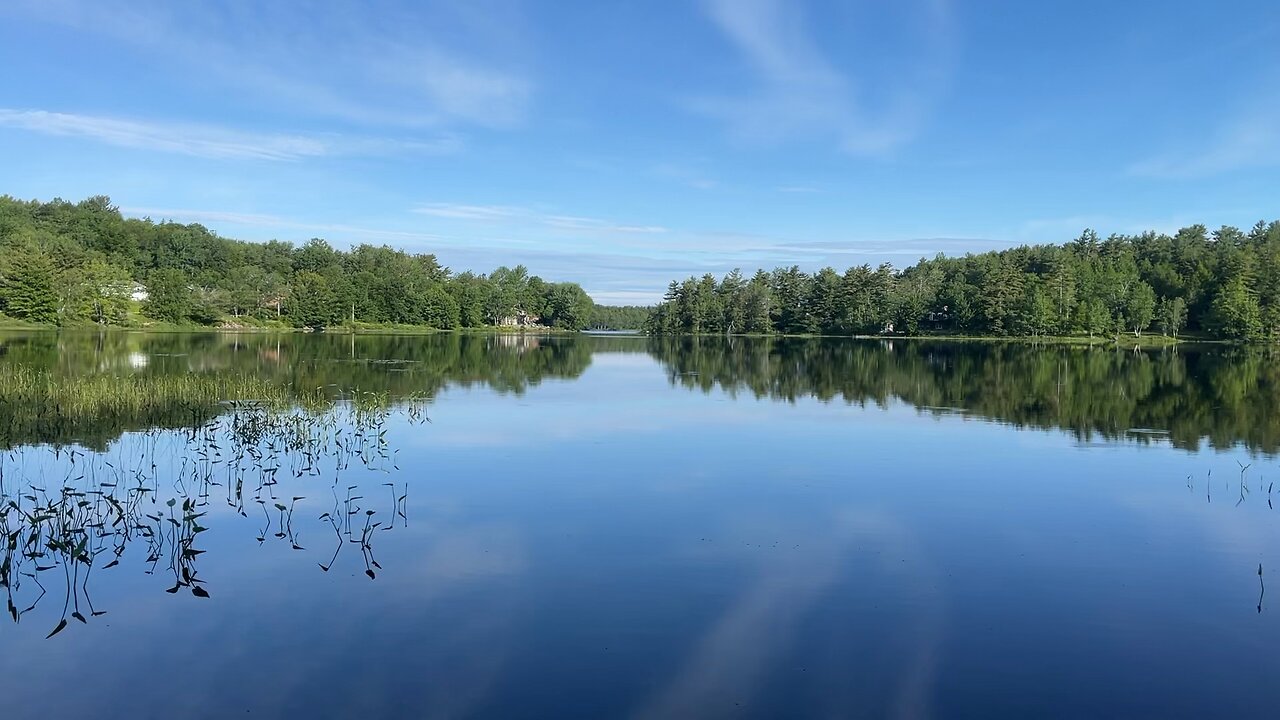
[0,334,1280,719]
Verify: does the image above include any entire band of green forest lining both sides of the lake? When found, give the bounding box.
[0,196,1280,341]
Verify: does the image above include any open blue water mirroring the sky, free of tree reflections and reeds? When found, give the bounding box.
[0,340,1280,717]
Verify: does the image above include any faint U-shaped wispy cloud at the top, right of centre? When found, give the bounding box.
[692,0,951,154]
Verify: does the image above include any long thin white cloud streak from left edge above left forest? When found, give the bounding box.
[0,108,458,160]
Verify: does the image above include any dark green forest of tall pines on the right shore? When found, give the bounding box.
[645,222,1280,341]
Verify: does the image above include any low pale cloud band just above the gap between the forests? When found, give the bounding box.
[122,204,1011,304]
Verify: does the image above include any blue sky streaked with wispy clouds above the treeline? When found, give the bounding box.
[0,0,1280,302]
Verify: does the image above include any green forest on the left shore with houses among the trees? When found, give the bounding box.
[0,196,604,331]
